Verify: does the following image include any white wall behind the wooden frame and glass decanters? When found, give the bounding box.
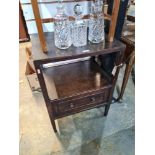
[20,0,91,34]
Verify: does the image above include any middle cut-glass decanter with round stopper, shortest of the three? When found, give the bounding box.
[72,4,87,47]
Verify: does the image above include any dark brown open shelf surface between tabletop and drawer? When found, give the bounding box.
[43,59,111,100]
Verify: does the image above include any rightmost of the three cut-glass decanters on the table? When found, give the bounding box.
[88,0,105,43]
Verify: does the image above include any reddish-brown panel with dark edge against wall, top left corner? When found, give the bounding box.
[19,2,30,42]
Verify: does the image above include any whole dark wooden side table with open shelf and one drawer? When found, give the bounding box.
[31,33,125,132]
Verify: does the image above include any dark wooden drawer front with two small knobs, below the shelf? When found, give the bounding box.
[54,89,109,115]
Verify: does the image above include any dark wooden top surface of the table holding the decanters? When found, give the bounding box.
[30,32,125,63]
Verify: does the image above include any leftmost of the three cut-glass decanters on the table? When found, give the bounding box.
[54,0,72,49]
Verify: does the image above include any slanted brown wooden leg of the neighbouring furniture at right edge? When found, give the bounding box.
[117,57,134,101]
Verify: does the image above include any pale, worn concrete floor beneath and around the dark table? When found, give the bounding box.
[19,43,135,155]
